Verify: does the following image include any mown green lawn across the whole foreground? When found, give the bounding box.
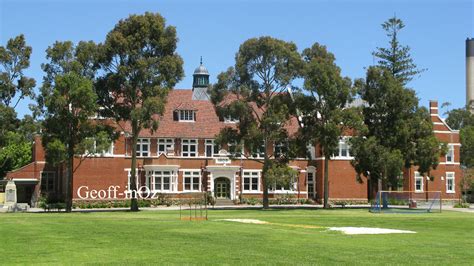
[0,210,474,265]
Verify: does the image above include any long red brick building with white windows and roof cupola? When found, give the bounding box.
[7,65,462,204]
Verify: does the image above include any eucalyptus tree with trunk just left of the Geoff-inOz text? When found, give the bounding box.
[37,41,113,212]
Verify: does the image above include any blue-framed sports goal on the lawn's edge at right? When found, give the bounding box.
[370,191,442,213]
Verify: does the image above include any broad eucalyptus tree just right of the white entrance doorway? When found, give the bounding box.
[210,37,301,208]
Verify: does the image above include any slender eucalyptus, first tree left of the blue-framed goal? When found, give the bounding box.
[295,43,361,208]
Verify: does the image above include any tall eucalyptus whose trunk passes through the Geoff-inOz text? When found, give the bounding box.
[97,12,183,211]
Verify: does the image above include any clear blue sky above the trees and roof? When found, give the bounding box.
[0,0,474,116]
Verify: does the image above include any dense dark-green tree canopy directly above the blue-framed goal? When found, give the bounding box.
[352,67,445,186]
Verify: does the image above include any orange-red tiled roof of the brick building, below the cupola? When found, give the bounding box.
[122,89,298,138]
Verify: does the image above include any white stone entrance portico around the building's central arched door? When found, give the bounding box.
[206,165,240,200]
